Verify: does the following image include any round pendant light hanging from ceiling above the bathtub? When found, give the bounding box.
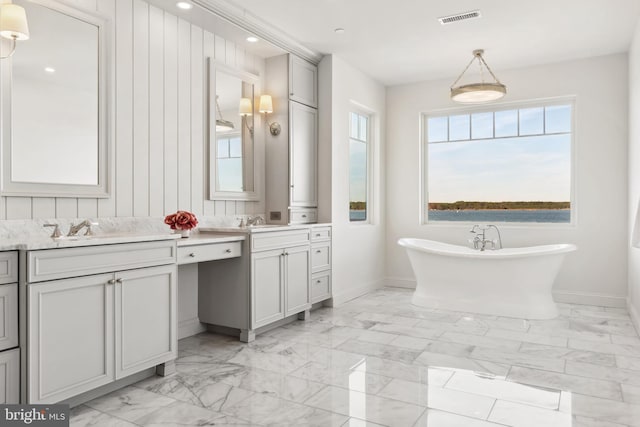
[451,49,507,104]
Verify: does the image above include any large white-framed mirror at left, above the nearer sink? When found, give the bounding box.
[0,0,109,198]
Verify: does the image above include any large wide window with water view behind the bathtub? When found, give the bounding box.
[423,100,574,223]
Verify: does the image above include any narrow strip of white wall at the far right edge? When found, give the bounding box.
[628,21,640,330]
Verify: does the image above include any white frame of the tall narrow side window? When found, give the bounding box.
[347,106,376,226]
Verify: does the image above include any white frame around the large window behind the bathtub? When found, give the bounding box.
[418,96,578,228]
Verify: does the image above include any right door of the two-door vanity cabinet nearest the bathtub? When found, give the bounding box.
[285,246,311,316]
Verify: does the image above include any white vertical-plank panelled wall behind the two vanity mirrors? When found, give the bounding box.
[0,0,264,220]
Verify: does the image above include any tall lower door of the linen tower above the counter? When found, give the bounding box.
[289,102,318,211]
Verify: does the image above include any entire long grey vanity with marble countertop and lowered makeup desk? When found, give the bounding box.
[0,224,331,405]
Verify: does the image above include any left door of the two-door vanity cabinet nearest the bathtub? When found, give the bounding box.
[251,249,284,329]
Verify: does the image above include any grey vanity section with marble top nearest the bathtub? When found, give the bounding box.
[198,224,331,342]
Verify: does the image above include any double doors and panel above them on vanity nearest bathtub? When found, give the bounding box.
[251,229,311,329]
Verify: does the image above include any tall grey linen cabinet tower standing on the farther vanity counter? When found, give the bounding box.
[265,54,318,224]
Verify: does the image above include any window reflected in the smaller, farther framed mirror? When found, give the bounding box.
[216,133,244,191]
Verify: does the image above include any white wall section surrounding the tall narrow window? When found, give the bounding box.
[319,55,386,303]
